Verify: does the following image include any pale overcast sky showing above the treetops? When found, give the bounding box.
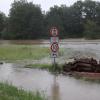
[0,0,100,15]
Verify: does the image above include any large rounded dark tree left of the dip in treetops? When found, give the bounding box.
[9,0,43,39]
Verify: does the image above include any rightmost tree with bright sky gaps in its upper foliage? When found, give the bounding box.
[83,0,100,39]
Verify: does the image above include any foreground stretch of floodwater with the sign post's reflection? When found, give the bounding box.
[0,63,100,100]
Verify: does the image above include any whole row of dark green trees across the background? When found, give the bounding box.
[0,0,100,39]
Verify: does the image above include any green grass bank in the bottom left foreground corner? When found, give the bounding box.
[0,83,46,100]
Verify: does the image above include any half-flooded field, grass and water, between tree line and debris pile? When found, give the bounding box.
[0,39,100,62]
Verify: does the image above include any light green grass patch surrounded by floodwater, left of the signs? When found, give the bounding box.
[0,45,50,60]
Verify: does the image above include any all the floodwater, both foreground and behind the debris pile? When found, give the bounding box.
[0,42,100,100]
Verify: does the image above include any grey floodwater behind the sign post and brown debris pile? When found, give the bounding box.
[33,42,100,63]
